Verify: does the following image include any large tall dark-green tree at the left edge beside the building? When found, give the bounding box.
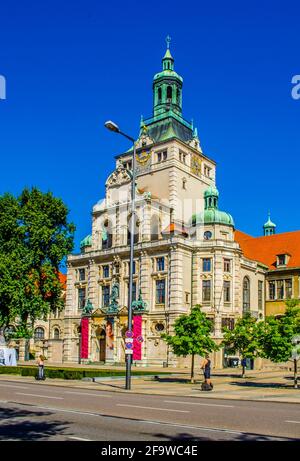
[0,188,75,331]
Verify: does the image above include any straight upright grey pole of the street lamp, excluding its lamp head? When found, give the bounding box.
[126,141,136,389]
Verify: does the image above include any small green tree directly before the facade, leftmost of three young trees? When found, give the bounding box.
[161,304,219,383]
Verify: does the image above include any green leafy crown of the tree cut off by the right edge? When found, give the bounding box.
[257,299,300,363]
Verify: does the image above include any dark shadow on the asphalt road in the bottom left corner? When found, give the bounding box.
[0,407,67,441]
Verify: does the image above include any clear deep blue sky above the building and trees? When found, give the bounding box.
[0,0,300,251]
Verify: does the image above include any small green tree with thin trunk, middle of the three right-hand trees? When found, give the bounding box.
[222,313,259,378]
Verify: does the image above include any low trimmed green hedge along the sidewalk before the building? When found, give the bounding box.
[0,365,170,379]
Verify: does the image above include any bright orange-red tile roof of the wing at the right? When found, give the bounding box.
[234,230,300,270]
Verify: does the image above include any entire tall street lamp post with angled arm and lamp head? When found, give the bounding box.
[104,120,136,389]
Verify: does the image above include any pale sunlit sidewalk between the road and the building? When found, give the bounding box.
[0,364,300,403]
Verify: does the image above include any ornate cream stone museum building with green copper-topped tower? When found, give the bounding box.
[63,43,266,367]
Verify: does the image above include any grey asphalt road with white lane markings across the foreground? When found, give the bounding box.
[0,380,300,441]
